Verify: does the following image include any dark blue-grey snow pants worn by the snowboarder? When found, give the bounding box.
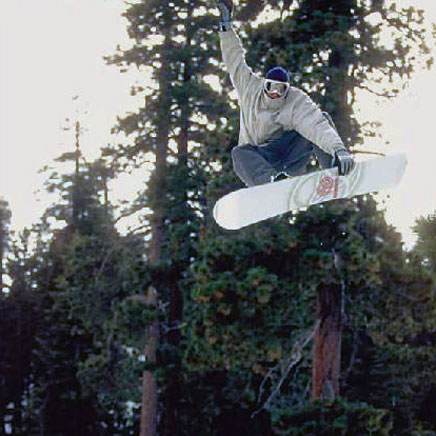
[232,130,333,186]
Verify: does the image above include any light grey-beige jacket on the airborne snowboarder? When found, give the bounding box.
[220,29,345,155]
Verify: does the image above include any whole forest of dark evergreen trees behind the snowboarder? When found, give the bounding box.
[0,0,436,436]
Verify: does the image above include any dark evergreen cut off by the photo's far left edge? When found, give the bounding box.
[0,230,40,435]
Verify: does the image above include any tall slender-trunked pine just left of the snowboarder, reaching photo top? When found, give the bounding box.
[107,1,233,435]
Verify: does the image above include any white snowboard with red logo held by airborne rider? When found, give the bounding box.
[213,153,407,230]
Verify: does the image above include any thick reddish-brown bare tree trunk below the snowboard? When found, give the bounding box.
[312,284,342,400]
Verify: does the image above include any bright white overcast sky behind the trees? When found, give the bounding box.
[0,0,436,243]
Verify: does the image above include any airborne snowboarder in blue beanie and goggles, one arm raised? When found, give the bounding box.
[217,0,354,186]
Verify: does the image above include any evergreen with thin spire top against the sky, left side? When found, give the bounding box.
[29,131,111,435]
